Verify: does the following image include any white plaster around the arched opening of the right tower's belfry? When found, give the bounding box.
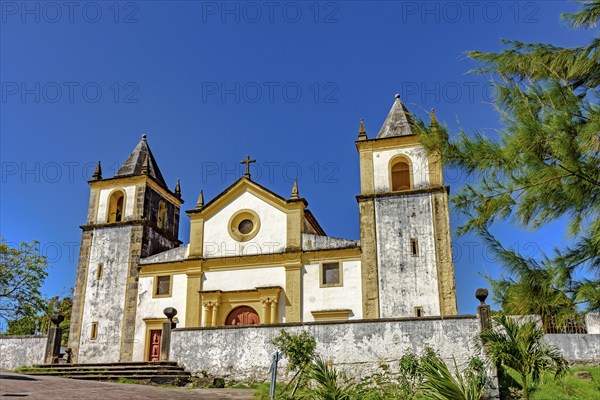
[373,146,429,193]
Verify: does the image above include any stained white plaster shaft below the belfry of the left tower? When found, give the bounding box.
[78,226,133,363]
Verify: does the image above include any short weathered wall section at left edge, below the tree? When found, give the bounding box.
[0,335,48,370]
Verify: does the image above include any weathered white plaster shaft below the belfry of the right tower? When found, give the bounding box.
[375,193,440,318]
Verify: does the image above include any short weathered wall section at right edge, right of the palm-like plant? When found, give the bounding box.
[544,334,600,364]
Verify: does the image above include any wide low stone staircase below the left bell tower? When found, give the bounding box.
[19,361,190,386]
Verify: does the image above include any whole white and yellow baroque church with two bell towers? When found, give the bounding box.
[69,95,457,363]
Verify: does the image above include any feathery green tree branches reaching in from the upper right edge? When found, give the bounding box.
[419,0,600,310]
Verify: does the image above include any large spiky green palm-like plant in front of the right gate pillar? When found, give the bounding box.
[479,315,569,399]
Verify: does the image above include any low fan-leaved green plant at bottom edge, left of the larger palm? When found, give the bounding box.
[421,356,487,400]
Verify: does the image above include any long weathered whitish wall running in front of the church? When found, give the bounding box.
[171,316,479,381]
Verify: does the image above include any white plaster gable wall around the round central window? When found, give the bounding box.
[204,192,287,258]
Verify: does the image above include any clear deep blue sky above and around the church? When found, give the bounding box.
[0,1,590,313]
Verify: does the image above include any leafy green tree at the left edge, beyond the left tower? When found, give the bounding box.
[0,237,48,323]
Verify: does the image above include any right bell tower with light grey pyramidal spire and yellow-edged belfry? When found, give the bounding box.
[356,95,457,318]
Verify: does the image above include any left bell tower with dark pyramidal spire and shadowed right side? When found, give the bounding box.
[69,135,183,363]
